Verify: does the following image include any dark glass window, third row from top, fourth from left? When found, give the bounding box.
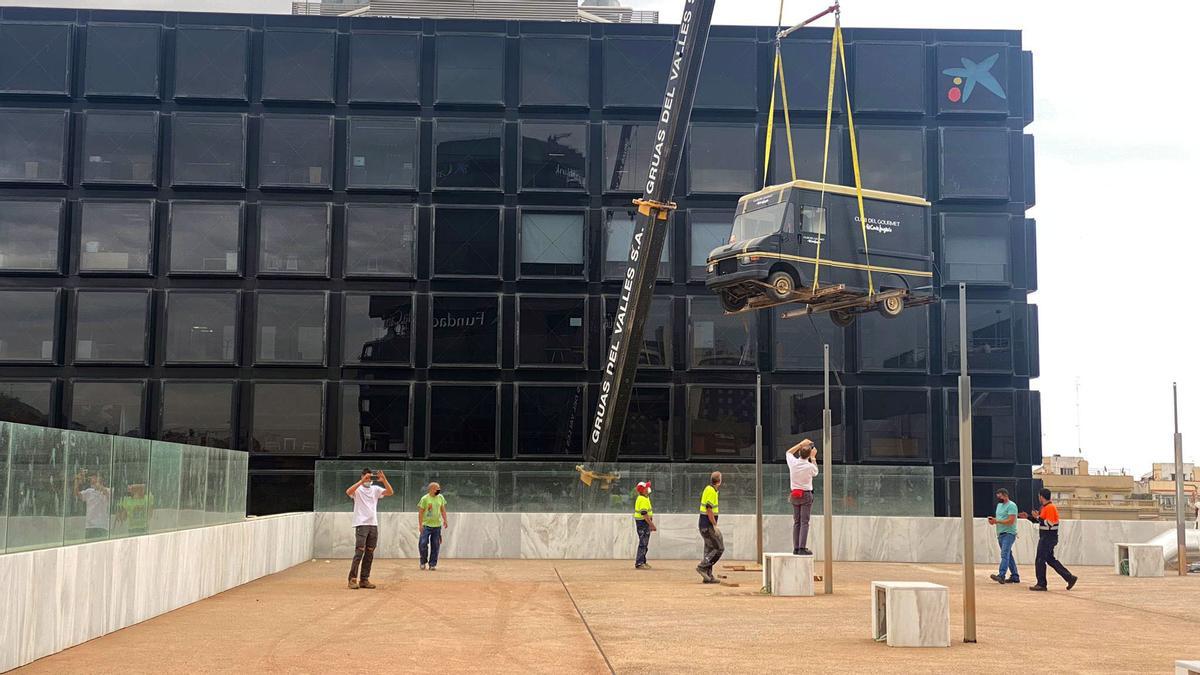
[258,203,330,276]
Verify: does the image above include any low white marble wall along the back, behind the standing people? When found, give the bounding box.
[313,512,1174,562]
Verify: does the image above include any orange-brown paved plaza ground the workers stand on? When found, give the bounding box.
[18,560,1200,674]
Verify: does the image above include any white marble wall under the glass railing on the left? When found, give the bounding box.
[0,513,314,671]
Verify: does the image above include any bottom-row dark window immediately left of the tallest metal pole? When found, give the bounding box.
[862,389,929,459]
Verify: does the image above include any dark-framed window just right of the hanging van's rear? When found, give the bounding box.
[942,214,1013,286]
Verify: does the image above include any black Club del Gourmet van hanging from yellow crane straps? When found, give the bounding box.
[706,180,934,311]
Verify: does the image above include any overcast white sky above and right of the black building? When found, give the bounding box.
[0,0,1200,473]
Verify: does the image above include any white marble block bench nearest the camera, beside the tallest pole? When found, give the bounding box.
[871,581,950,647]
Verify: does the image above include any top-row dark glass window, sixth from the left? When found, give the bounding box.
[437,35,504,103]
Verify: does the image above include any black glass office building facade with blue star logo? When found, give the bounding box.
[0,7,1042,514]
